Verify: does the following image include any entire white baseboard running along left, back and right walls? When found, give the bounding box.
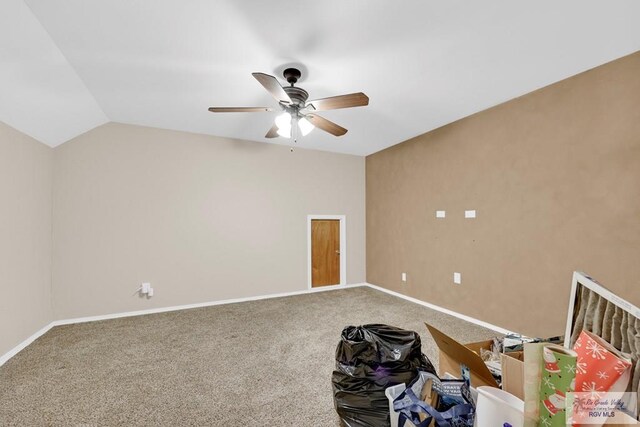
[0,283,510,366]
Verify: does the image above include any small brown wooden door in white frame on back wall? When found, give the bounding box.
[311,219,340,287]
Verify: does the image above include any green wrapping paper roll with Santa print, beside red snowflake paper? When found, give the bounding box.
[538,344,578,427]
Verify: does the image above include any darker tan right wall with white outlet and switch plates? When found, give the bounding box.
[366,53,640,335]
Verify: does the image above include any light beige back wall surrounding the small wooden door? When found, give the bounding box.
[53,123,365,319]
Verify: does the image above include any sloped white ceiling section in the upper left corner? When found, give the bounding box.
[0,0,109,146]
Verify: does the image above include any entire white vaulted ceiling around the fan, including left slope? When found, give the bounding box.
[5,0,640,155]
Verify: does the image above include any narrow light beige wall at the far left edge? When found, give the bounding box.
[0,122,53,356]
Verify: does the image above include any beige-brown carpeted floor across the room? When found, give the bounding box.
[0,287,495,427]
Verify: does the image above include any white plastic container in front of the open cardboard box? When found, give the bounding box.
[475,386,524,427]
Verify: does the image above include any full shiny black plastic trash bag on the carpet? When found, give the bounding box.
[332,324,436,427]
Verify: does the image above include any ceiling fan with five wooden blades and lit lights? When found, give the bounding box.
[209,68,369,138]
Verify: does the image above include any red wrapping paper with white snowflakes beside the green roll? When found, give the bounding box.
[573,330,631,425]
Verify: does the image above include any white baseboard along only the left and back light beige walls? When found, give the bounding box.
[0,283,367,366]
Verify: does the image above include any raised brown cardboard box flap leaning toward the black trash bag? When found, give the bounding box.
[425,323,498,387]
